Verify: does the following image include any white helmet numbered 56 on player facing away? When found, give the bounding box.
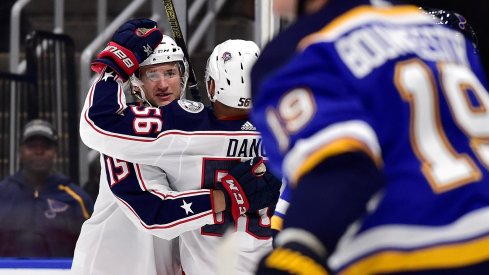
[205,39,260,109]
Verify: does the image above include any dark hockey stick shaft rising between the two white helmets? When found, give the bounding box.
[163,0,201,101]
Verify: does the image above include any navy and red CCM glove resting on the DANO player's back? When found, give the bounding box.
[218,157,282,221]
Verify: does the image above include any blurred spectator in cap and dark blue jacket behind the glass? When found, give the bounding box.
[0,119,93,257]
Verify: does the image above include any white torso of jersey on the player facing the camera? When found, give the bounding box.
[71,155,182,275]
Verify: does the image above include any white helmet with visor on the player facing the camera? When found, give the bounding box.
[131,35,189,104]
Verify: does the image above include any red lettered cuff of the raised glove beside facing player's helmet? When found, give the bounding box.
[92,41,139,81]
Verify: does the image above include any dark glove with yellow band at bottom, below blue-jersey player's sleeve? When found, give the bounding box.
[255,242,330,275]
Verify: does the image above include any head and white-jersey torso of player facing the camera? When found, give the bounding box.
[72,35,188,275]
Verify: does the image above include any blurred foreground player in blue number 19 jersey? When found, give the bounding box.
[252,0,489,275]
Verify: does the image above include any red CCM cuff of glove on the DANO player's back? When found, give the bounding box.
[218,174,250,221]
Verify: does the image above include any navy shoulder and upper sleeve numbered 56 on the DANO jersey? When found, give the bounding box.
[83,70,255,138]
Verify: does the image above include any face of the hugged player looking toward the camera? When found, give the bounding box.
[140,62,182,106]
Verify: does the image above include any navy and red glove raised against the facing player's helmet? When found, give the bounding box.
[91,19,163,81]
